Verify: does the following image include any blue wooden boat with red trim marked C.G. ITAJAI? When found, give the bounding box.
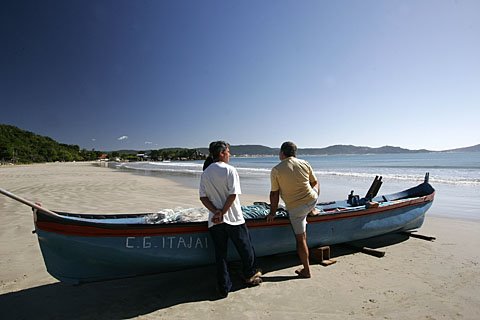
[0,173,435,284]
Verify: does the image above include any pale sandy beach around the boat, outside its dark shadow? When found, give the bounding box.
[0,163,480,319]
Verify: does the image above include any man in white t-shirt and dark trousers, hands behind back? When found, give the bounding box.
[199,141,261,297]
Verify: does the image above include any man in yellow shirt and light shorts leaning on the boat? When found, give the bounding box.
[267,142,320,278]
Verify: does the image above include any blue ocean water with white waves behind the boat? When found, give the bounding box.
[112,152,480,220]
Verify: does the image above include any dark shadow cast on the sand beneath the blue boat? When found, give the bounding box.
[0,234,408,320]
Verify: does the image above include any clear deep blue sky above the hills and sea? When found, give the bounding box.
[0,0,480,150]
